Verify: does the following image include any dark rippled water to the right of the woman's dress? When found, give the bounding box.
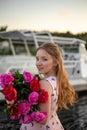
[58,91,87,130]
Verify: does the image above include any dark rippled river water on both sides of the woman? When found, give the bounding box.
[0,91,87,130]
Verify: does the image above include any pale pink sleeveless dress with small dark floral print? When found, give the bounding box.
[20,76,64,130]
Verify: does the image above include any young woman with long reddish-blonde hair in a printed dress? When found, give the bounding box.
[20,43,76,130]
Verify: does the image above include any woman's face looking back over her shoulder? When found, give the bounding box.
[36,49,55,77]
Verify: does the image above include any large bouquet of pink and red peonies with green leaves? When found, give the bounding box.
[0,71,48,123]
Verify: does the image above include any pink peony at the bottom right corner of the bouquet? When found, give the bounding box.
[31,112,46,122]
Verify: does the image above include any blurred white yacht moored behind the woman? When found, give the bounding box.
[0,31,87,96]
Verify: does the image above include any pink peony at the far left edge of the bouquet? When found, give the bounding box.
[0,74,14,88]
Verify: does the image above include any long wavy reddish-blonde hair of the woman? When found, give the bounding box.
[37,42,77,109]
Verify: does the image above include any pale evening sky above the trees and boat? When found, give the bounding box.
[0,0,87,33]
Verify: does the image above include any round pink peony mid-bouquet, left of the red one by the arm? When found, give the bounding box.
[28,92,39,104]
